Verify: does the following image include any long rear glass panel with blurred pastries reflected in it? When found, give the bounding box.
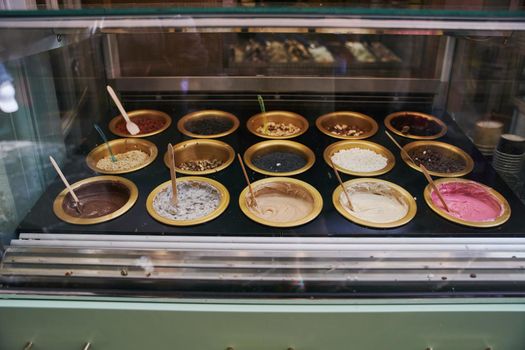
[115,33,444,79]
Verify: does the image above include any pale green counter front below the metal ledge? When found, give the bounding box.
[0,295,525,350]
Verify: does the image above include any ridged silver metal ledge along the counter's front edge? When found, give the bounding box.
[0,234,525,298]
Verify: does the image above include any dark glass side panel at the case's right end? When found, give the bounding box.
[448,33,525,200]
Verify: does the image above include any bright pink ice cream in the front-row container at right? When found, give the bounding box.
[430,182,503,222]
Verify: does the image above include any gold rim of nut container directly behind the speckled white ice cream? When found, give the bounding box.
[164,139,235,175]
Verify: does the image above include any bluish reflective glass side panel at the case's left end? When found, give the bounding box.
[0,32,105,243]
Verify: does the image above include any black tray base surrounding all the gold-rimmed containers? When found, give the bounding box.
[18,96,525,237]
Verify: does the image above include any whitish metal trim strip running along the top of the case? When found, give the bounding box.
[0,14,525,31]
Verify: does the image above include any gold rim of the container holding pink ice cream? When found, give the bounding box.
[423,178,511,228]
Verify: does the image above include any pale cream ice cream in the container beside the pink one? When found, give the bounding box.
[339,182,408,224]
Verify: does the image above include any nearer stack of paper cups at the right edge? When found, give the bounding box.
[492,134,525,181]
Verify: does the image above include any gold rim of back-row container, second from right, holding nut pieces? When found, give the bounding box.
[315,111,379,140]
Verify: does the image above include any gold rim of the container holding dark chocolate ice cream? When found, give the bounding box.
[53,175,139,225]
